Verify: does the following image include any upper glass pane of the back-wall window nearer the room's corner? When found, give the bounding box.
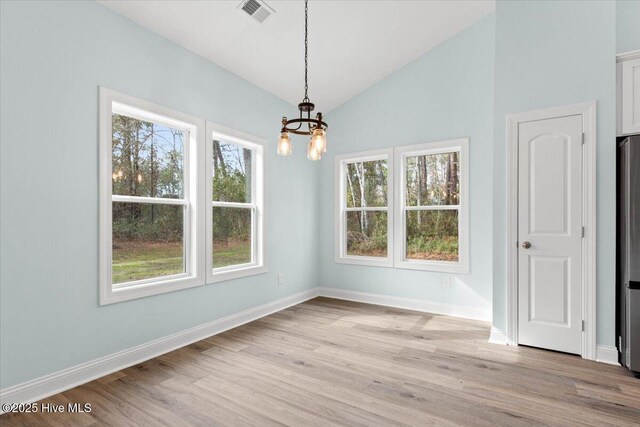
[346,160,387,208]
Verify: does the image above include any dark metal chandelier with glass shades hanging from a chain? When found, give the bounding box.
[278,0,329,160]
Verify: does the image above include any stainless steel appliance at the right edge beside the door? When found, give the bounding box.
[616,135,640,376]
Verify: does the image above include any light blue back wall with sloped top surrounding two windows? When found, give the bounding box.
[319,14,494,320]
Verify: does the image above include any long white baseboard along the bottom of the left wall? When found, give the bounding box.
[0,288,318,414]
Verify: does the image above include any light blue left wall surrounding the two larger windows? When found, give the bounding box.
[0,1,318,388]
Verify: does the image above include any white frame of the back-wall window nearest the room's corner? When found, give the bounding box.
[335,149,394,267]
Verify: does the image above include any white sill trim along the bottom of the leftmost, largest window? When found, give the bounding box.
[100,276,204,305]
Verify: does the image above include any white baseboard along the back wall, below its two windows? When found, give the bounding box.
[318,288,491,321]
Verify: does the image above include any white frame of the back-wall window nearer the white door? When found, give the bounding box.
[394,138,469,274]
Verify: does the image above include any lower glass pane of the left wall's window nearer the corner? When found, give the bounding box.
[213,206,253,268]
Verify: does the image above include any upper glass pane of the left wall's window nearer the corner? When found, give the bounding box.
[212,141,253,203]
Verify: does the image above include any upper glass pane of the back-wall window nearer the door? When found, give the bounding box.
[405,151,460,206]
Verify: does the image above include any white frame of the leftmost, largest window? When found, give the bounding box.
[99,87,205,305]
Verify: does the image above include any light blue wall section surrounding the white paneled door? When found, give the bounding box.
[493,1,616,345]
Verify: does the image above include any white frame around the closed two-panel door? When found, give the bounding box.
[506,101,596,360]
